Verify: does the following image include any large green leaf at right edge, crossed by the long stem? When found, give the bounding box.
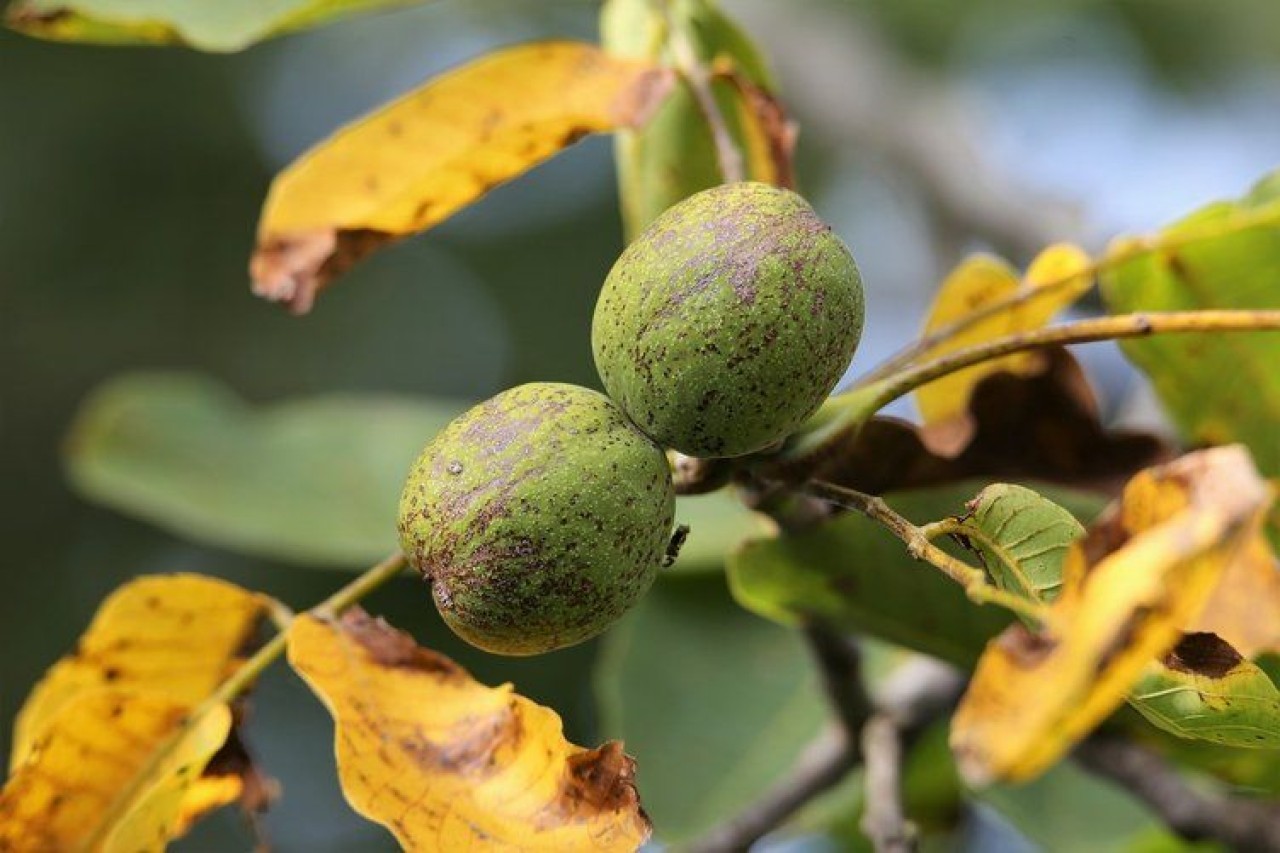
[1102,173,1280,476]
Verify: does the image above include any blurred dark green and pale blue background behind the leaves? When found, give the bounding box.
[0,0,1280,850]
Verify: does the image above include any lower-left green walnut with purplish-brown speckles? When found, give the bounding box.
[399,383,676,654]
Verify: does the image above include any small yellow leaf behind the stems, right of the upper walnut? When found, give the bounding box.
[915,243,1092,447]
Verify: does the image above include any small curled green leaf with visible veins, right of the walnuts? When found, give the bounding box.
[959,483,1084,601]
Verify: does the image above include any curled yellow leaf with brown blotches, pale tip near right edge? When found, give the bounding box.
[951,446,1271,784]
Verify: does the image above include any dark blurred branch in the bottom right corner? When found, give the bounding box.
[1075,734,1280,852]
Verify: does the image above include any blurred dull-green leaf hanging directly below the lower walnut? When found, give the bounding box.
[595,575,827,843]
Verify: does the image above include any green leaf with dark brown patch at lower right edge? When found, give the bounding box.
[1129,634,1280,749]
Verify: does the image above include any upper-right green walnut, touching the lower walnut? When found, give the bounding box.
[591,183,863,456]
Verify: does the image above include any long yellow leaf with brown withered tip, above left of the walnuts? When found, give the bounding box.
[250,41,671,313]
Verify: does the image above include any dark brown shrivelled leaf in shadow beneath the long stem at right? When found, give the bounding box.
[823,350,1170,494]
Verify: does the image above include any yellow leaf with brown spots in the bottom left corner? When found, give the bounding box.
[0,575,271,852]
